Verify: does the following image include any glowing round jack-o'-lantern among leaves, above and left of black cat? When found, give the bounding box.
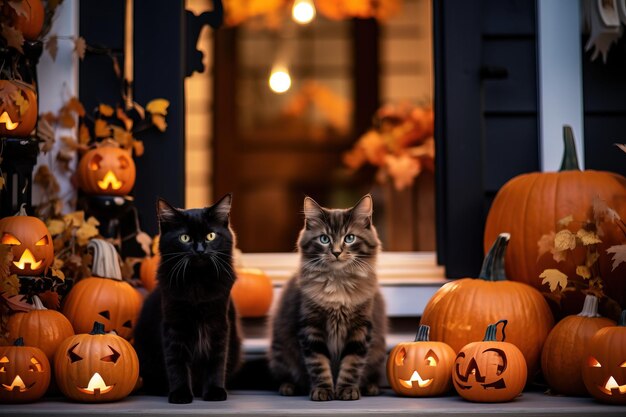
[76,141,136,195]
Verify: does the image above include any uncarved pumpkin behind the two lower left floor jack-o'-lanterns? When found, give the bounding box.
[7,296,74,363]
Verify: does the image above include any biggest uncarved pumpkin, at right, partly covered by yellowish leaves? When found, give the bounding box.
[484,126,626,308]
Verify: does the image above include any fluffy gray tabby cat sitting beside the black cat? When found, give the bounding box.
[269,194,387,401]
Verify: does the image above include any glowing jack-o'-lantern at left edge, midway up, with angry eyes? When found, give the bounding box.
[0,205,54,276]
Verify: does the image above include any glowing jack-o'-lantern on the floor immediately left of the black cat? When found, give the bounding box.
[54,322,139,403]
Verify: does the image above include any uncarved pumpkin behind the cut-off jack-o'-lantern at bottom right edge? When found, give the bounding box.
[541,295,615,395]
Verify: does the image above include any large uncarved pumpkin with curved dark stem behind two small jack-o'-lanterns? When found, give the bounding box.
[421,233,554,378]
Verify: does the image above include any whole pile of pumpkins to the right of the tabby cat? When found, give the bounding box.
[387,126,626,404]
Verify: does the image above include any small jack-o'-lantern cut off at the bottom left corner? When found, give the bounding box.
[0,337,50,403]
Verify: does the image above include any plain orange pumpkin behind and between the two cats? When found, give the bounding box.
[230,268,274,317]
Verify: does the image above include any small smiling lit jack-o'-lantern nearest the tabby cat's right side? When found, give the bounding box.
[387,324,456,397]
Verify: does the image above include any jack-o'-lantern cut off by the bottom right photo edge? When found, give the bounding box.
[582,310,626,404]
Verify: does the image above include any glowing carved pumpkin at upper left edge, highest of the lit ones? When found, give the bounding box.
[0,80,38,138]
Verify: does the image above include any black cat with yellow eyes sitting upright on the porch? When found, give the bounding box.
[135,194,241,404]
